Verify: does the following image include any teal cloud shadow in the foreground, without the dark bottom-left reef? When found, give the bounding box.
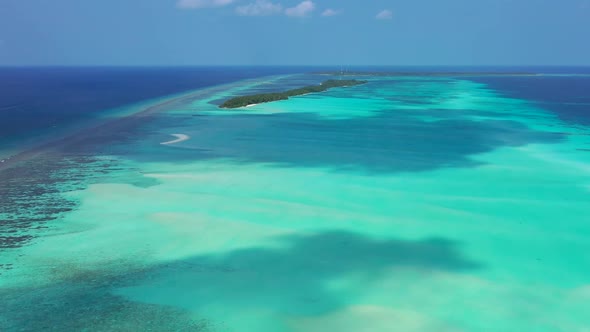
[122,232,483,315]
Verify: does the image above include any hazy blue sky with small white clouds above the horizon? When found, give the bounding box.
[0,0,590,65]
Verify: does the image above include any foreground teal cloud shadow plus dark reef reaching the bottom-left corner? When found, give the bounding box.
[0,231,483,331]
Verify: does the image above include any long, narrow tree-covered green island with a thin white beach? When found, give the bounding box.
[219,80,367,108]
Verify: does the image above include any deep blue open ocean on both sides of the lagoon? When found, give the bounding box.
[0,66,590,150]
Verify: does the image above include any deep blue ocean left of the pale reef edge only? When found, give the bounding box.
[0,67,308,150]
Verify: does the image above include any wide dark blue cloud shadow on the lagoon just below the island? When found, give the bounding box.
[129,112,563,173]
